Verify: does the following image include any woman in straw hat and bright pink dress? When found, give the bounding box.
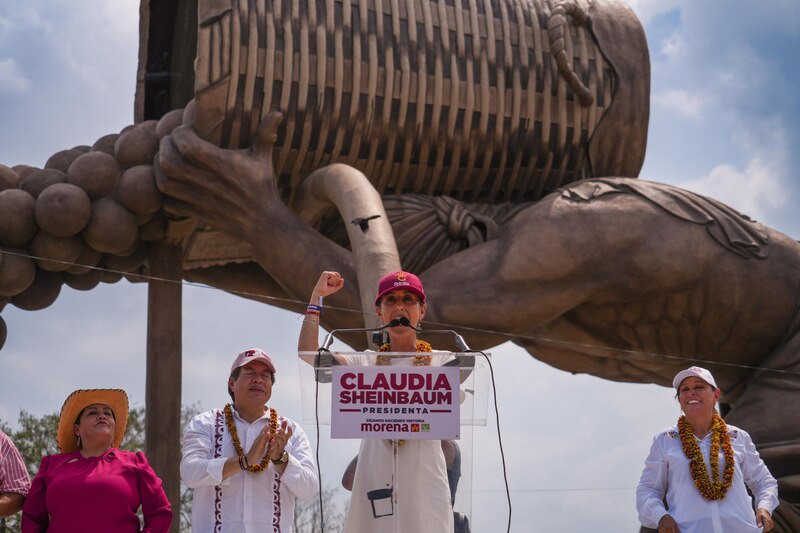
[22,389,172,533]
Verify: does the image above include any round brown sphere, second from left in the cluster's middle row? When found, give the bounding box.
[35,183,92,237]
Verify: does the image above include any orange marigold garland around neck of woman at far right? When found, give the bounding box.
[678,413,734,501]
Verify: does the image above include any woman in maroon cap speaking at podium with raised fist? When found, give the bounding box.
[298,272,453,533]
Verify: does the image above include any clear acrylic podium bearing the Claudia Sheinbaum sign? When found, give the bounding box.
[299,352,490,533]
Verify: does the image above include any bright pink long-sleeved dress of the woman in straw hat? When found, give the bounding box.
[22,448,172,533]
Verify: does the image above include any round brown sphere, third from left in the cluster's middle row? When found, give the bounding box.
[83,198,139,254]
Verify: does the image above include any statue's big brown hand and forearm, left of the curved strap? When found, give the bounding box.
[157,113,360,323]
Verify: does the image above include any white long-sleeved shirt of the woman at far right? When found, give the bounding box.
[636,425,778,533]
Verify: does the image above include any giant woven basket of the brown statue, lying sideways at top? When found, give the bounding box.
[195,0,649,203]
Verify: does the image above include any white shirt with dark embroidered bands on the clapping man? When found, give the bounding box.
[181,409,318,533]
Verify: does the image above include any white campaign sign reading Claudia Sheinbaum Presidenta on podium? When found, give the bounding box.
[331,366,460,439]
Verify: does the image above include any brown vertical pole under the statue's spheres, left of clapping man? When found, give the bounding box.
[145,243,182,533]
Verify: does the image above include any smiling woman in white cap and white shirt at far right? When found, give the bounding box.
[636,366,778,533]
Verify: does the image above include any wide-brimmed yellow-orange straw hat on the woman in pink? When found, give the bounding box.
[56,389,128,453]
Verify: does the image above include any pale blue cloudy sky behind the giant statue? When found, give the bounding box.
[0,0,800,533]
